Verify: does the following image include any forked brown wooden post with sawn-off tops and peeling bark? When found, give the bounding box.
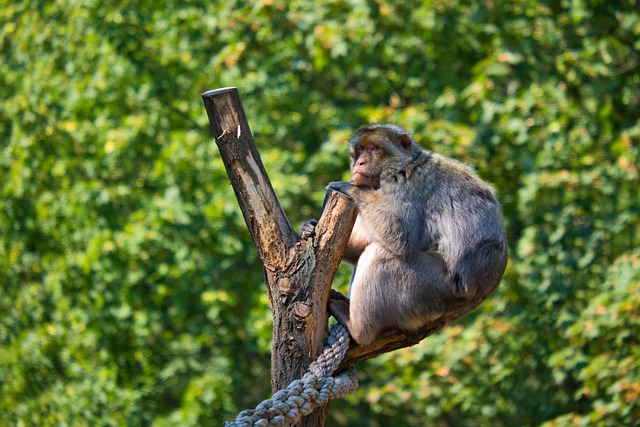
[202,88,357,426]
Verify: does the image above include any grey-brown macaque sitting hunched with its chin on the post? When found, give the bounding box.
[312,124,507,345]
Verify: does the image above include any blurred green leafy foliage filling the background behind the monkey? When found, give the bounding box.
[0,0,640,426]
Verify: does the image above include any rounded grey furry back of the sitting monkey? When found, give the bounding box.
[420,153,507,293]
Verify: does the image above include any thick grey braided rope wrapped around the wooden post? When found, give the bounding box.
[224,324,358,427]
